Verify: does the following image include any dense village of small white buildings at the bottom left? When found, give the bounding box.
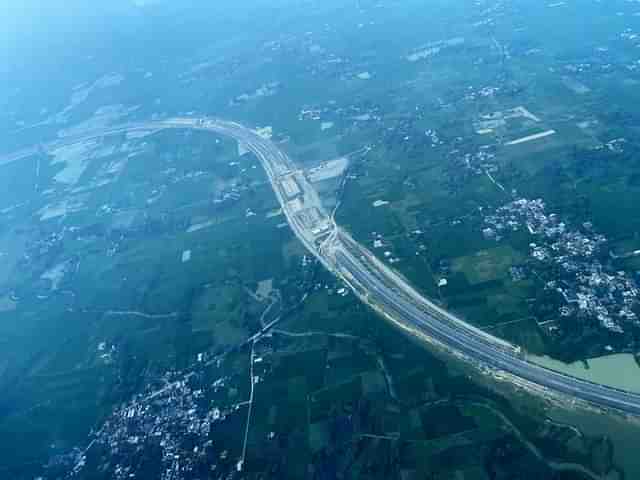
[68,364,240,480]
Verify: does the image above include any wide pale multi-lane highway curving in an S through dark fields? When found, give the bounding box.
[7,118,640,415]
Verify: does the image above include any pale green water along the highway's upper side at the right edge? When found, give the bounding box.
[527,353,640,393]
